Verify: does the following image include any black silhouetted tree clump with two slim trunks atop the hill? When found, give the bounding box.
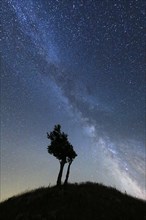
[47,124,77,186]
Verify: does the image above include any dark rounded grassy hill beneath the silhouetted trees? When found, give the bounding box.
[0,183,146,220]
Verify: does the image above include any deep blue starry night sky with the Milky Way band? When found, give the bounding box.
[1,0,146,200]
